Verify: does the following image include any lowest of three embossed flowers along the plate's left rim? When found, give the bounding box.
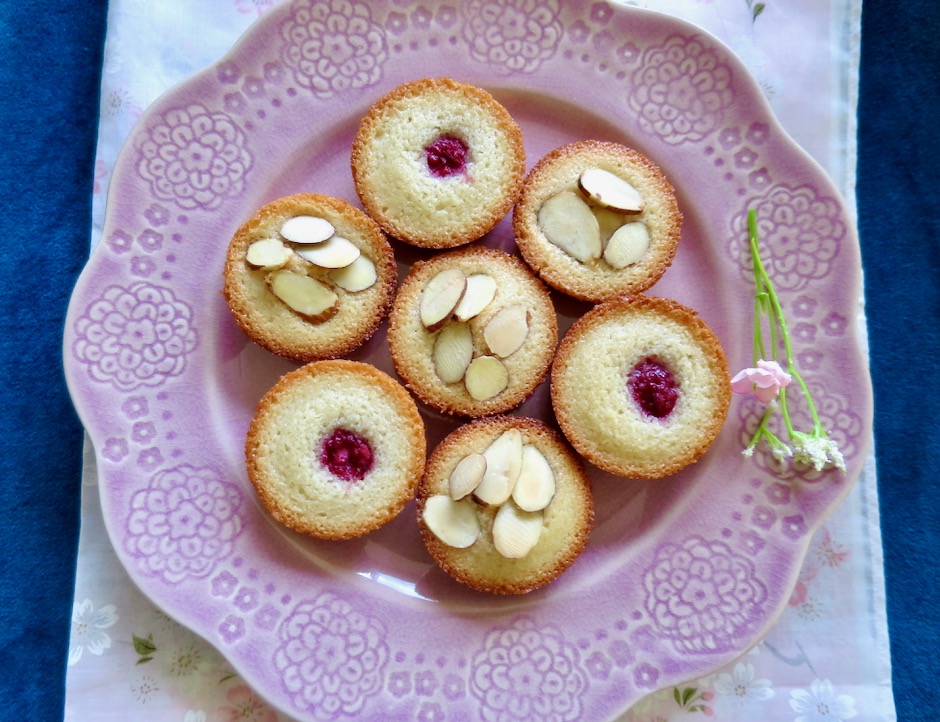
[124,464,243,583]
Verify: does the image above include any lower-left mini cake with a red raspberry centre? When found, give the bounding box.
[245,359,426,539]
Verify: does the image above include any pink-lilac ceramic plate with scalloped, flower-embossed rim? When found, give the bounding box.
[64,0,871,721]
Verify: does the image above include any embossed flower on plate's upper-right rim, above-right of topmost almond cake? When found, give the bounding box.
[630,35,734,145]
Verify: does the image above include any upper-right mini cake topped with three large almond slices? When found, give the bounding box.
[513,140,682,302]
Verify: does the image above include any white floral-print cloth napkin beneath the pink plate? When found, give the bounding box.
[66,0,895,722]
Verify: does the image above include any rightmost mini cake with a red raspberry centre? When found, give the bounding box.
[551,295,731,479]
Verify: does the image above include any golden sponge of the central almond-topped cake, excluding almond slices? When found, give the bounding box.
[388,246,558,417]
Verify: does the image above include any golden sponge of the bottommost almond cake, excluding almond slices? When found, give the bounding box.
[416,416,594,594]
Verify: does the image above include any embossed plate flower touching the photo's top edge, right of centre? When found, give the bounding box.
[461,0,562,73]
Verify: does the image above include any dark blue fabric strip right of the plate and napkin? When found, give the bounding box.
[856,0,940,721]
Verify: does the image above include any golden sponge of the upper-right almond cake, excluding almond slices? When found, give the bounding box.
[513,140,682,302]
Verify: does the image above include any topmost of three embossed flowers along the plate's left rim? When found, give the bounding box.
[137,104,252,210]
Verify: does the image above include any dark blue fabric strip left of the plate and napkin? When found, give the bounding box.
[0,0,106,720]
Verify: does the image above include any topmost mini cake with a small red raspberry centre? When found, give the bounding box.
[351,78,525,248]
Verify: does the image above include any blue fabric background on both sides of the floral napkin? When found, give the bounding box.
[0,0,940,720]
